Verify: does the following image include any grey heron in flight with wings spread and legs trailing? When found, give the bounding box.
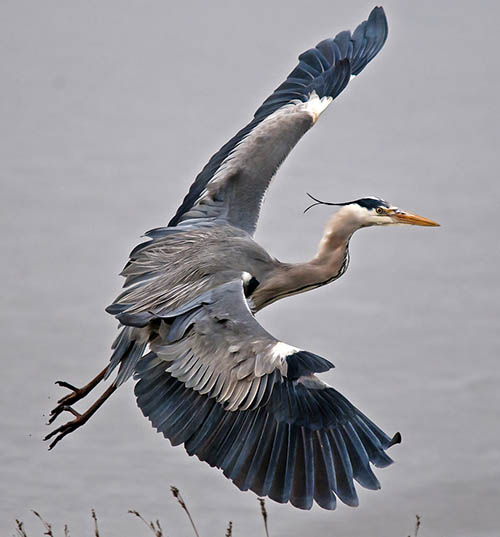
[45,7,438,509]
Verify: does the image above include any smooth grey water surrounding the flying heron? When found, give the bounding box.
[0,0,500,537]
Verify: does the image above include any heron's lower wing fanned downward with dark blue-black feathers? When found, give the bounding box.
[135,280,399,509]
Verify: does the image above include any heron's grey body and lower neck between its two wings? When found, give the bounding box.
[109,218,348,319]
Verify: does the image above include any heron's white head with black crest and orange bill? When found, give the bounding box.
[304,194,439,229]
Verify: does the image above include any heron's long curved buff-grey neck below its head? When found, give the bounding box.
[251,210,359,310]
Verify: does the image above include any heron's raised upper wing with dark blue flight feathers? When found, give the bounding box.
[169,7,387,233]
